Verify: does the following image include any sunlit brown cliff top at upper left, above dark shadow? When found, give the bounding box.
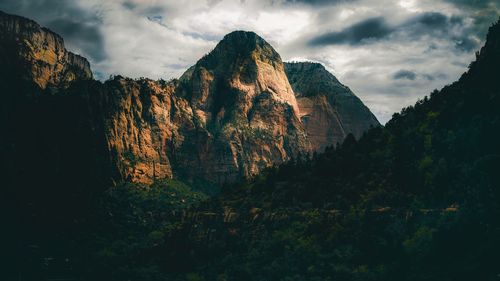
[0,11,92,89]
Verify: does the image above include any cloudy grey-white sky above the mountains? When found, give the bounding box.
[0,0,500,123]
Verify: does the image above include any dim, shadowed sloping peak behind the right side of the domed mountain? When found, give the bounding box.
[285,62,380,152]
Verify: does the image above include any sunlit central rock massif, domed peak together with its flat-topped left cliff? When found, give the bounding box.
[100,32,310,184]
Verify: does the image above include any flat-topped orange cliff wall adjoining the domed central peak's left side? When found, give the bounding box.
[95,77,178,182]
